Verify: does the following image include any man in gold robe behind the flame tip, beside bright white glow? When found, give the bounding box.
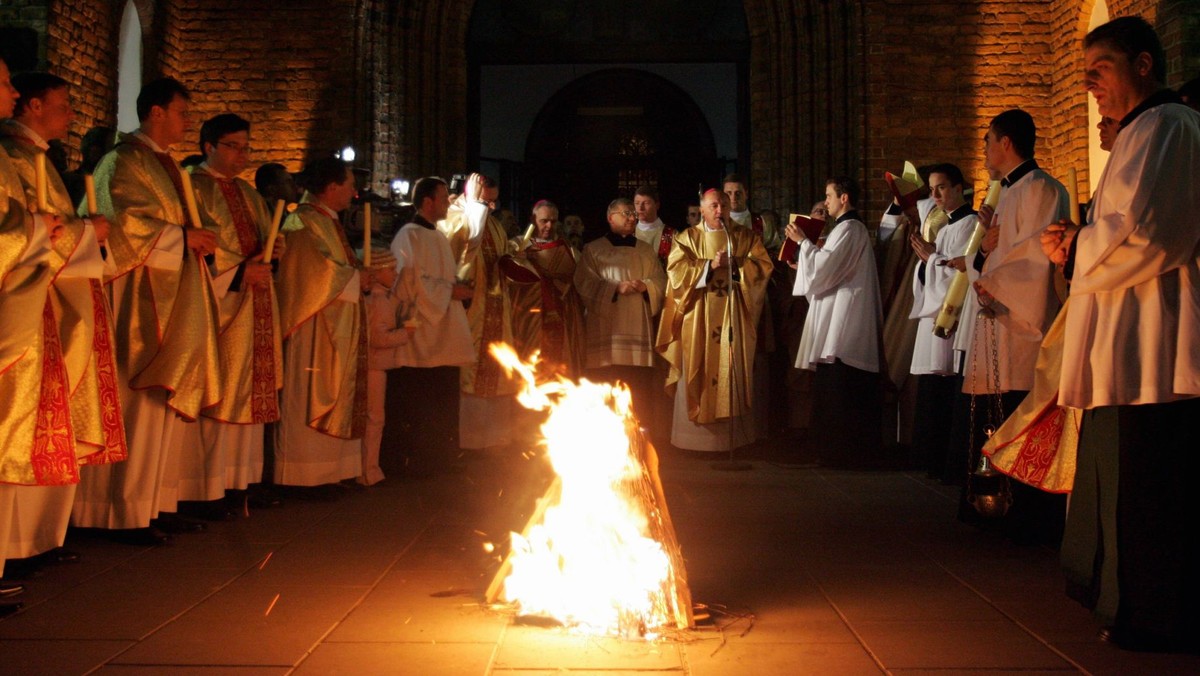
[438,174,517,449]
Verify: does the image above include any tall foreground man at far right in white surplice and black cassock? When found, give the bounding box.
[1042,17,1200,652]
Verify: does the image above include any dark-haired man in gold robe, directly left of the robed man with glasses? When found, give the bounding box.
[72,78,221,544]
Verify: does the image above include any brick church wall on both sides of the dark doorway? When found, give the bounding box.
[7,0,1200,200]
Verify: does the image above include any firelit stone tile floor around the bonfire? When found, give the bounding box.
[0,454,1200,676]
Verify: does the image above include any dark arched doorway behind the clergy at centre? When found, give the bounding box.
[524,68,724,239]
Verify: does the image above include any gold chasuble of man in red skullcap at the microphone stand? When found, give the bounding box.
[655,223,774,424]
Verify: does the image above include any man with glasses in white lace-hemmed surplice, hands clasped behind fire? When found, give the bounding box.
[575,198,667,427]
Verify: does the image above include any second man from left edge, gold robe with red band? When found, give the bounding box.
[0,72,127,564]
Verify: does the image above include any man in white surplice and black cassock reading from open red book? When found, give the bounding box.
[786,177,882,467]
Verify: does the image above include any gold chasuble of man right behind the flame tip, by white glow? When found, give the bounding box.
[438,202,517,397]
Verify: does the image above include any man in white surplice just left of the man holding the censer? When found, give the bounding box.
[908,163,978,477]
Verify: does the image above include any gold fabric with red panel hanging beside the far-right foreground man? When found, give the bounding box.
[983,298,1082,493]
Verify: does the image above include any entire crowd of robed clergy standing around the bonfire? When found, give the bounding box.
[0,13,1200,650]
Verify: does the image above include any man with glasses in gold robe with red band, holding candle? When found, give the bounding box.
[180,113,283,518]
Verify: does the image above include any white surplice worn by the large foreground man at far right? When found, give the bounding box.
[1058,103,1200,408]
